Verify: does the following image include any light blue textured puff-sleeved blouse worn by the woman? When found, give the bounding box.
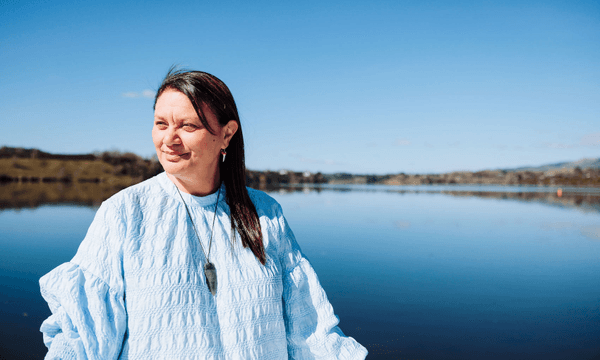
[40,173,367,360]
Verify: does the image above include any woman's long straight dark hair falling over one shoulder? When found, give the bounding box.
[154,67,266,265]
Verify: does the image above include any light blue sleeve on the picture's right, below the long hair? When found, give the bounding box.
[278,208,367,359]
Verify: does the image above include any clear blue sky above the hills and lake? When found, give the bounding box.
[0,0,600,174]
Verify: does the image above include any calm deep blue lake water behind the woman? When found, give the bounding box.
[0,188,600,359]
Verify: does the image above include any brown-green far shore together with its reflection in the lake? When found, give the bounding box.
[0,147,600,212]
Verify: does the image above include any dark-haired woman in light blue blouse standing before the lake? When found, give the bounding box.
[40,70,367,360]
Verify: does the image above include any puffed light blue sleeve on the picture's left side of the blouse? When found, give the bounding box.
[40,202,127,360]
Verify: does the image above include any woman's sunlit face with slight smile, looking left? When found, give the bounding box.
[152,89,237,181]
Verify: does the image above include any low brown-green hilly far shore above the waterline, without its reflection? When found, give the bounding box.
[0,147,600,189]
